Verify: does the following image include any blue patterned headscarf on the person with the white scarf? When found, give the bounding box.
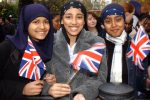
[101,3,125,23]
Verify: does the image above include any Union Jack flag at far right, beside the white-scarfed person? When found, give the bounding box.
[127,26,150,70]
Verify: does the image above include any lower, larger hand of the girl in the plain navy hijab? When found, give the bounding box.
[22,80,44,96]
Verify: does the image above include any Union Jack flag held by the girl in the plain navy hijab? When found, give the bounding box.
[19,37,46,80]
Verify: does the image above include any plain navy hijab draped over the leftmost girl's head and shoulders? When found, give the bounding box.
[6,4,53,62]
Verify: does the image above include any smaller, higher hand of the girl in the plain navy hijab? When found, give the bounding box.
[44,74,56,85]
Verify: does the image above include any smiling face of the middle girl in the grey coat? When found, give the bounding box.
[62,8,85,39]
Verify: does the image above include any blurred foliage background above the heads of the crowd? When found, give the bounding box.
[0,0,150,24]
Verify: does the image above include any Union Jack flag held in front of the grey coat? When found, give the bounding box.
[71,43,105,73]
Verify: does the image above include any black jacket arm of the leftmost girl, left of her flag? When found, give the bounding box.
[0,41,31,100]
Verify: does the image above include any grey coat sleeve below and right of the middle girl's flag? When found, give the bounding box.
[71,41,107,100]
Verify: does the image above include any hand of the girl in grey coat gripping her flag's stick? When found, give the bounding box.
[48,83,71,98]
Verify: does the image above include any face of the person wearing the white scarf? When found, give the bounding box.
[104,15,125,37]
